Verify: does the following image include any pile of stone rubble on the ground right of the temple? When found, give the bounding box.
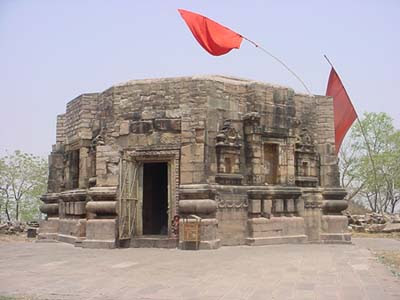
[346,212,400,233]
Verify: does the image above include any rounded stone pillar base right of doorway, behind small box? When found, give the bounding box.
[179,184,220,249]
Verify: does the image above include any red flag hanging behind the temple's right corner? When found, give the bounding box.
[326,67,357,154]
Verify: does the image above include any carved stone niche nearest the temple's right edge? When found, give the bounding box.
[295,128,319,187]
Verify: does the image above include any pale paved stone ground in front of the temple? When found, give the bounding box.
[0,239,400,300]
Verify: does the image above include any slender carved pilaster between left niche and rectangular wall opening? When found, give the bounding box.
[243,112,265,185]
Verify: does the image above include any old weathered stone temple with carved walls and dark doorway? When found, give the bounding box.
[39,76,350,249]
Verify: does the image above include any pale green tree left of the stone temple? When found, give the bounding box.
[0,151,48,221]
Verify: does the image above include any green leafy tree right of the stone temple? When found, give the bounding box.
[339,113,400,213]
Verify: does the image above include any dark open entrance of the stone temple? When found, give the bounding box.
[142,163,168,235]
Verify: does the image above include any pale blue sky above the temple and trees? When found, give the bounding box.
[0,0,400,156]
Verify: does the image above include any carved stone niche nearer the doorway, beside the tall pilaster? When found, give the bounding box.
[215,120,243,185]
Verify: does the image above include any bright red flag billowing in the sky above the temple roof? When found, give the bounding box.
[178,9,243,56]
